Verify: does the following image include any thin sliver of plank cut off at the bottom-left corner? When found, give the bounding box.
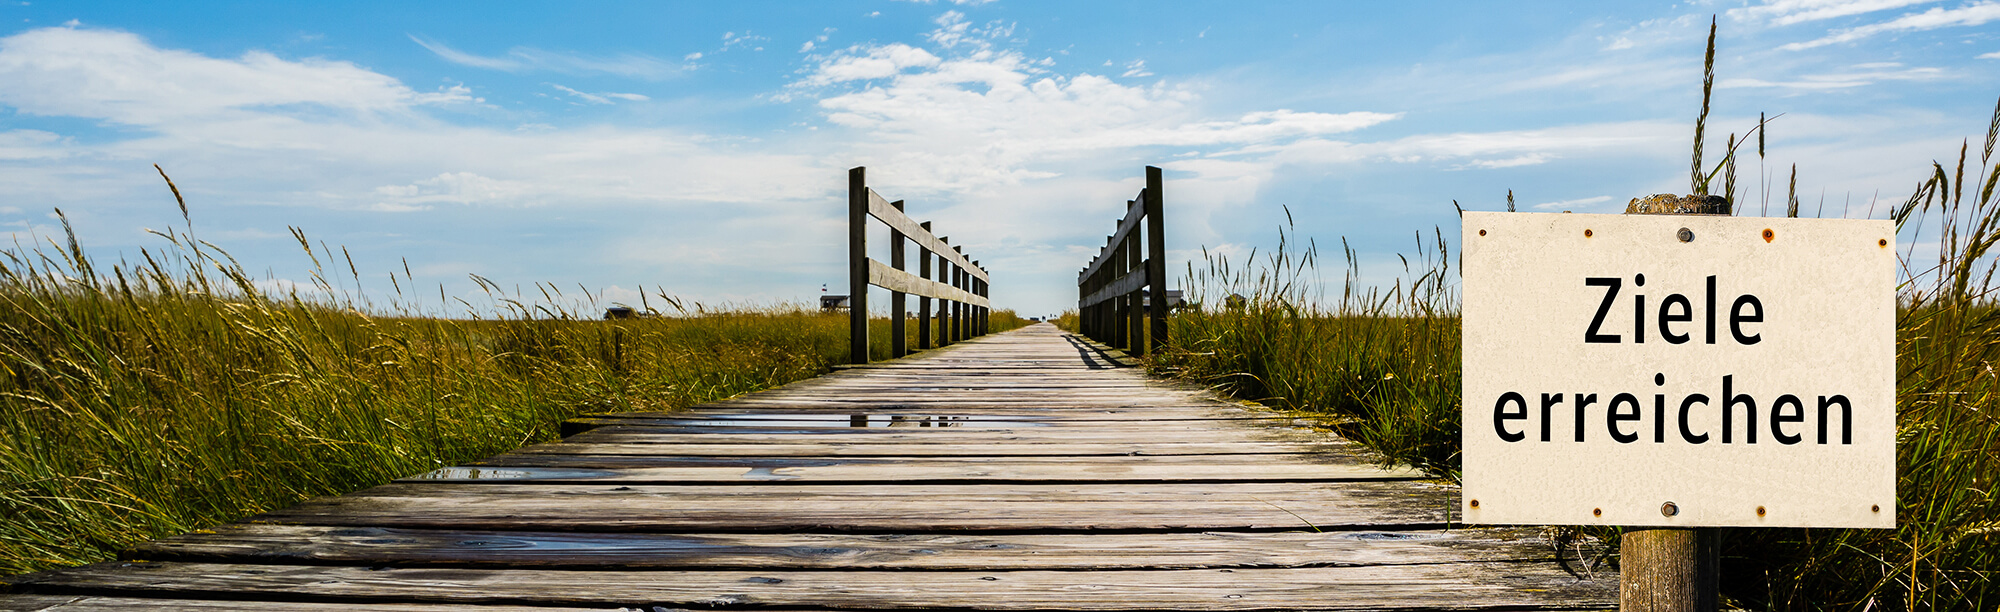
[0,596,624,612]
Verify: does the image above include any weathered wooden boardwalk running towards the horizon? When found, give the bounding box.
[0,324,1618,610]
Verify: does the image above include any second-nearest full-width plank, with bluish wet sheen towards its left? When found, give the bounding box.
[126,524,1554,570]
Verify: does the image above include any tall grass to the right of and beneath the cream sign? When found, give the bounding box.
[1732,108,2000,610]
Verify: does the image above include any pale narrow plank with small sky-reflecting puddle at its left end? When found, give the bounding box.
[396,462,1424,484]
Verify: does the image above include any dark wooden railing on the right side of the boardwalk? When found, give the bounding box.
[1076,166,1168,356]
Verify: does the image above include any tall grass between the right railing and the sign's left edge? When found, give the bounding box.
[1150,228,1458,478]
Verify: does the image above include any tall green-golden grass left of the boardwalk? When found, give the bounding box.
[0,194,1022,574]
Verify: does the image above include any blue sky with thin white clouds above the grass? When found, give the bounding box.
[0,0,2000,314]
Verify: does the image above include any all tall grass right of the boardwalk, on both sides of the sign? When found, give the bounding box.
[1150,143,2000,610]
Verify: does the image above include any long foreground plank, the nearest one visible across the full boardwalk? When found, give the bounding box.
[0,562,1616,610]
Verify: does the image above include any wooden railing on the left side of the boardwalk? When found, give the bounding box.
[848,168,990,364]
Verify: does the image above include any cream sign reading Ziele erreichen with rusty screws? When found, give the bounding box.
[1462,212,1896,528]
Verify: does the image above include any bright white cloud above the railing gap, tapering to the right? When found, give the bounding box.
[796,44,1398,188]
